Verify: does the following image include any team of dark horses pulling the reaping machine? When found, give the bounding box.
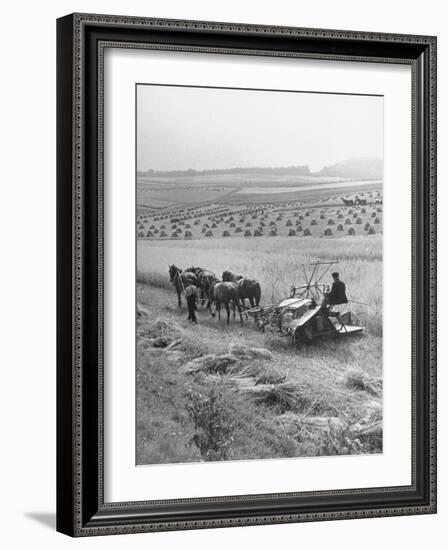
[168,265,261,324]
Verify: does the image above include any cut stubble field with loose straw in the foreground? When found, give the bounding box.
[136,284,382,464]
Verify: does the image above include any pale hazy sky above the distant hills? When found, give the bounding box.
[137,85,383,172]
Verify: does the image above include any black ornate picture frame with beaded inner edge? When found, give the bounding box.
[57,14,437,536]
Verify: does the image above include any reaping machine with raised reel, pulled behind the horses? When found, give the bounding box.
[247,262,364,344]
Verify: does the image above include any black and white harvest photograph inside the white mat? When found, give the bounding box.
[135,83,384,465]
